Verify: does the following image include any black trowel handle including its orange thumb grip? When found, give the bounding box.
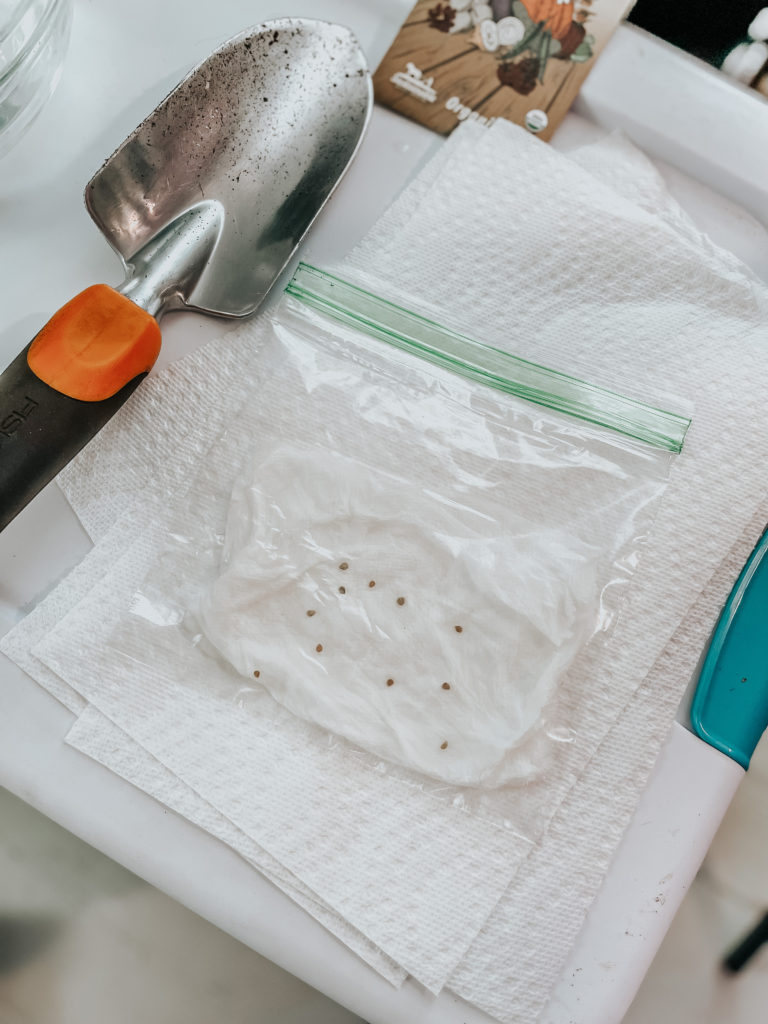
[0,285,160,529]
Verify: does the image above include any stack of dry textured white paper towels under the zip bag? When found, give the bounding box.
[2,116,768,1024]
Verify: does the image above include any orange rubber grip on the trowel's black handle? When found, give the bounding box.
[27,285,161,401]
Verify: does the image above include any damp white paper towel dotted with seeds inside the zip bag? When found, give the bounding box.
[200,445,598,785]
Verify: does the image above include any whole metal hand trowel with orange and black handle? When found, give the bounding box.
[0,18,372,529]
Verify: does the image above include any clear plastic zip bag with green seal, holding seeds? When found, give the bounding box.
[115,266,689,793]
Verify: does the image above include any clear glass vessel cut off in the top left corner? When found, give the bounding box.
[0,0,72,157]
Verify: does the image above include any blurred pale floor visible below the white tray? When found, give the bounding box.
[0,741,768,1024]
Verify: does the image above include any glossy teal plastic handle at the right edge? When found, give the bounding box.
[690,531,768,768]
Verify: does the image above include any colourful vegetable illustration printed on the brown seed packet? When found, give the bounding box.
[427,0,595,96]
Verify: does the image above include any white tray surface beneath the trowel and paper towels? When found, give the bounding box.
[0,0,768,1024]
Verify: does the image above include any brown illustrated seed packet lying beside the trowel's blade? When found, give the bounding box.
[374,0,632,139]
